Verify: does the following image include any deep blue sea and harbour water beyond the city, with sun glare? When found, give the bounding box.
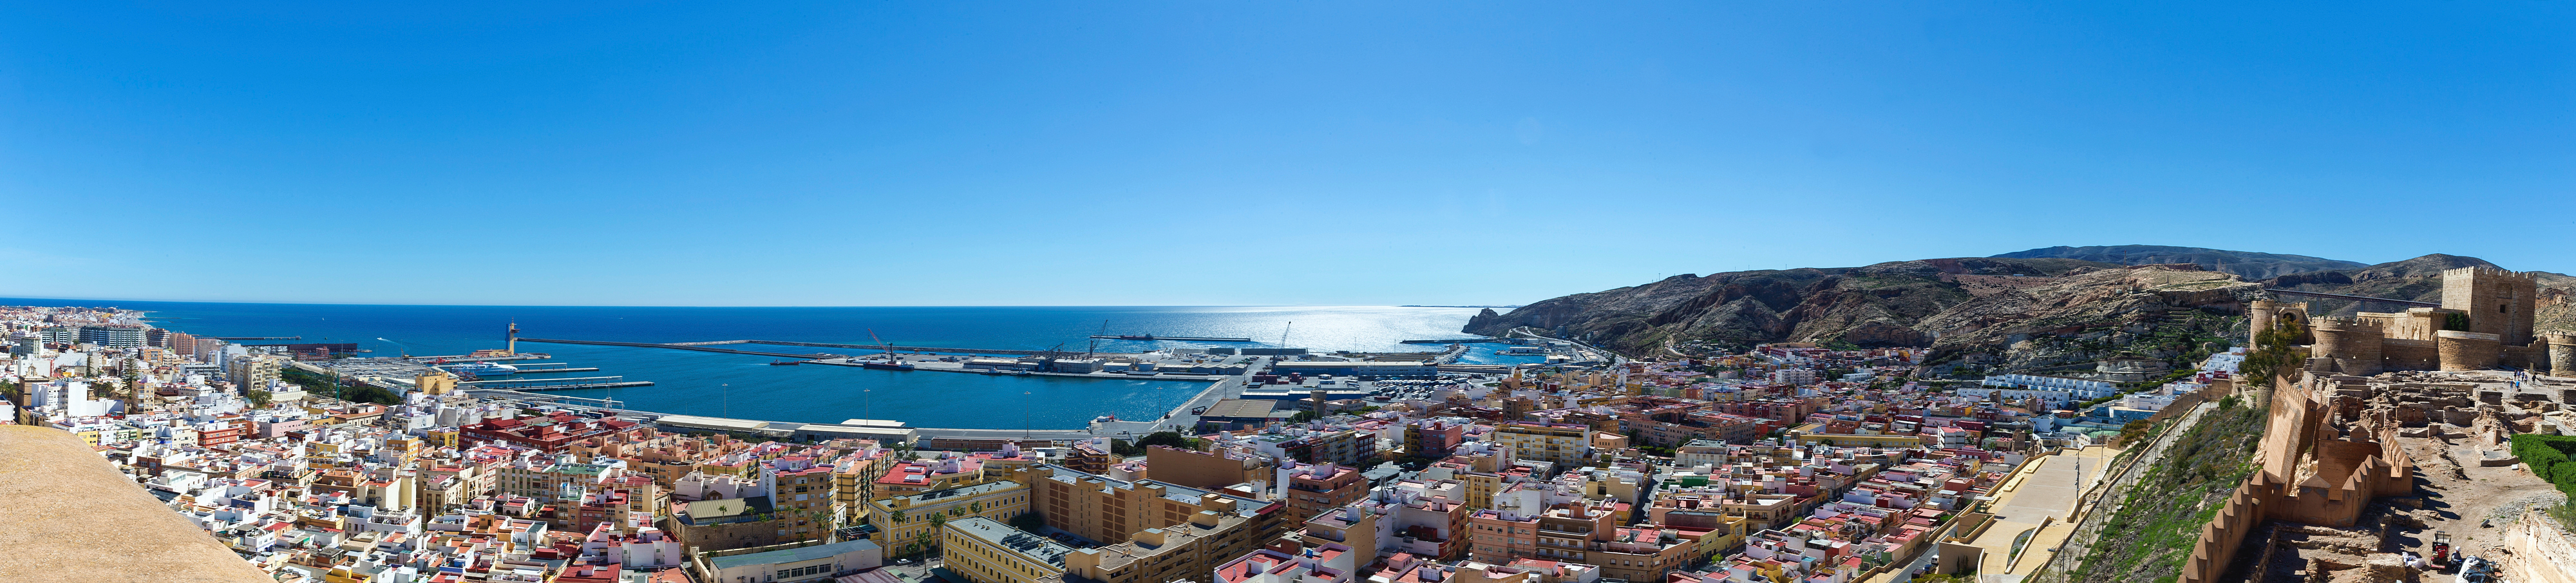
[0,300,1538,428]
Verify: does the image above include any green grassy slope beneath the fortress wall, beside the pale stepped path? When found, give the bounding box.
[2063,397,2269,583]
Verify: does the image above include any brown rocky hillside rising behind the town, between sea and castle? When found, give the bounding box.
[1466,258,2259,369]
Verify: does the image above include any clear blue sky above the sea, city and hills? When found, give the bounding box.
[0,0,2576,305]
